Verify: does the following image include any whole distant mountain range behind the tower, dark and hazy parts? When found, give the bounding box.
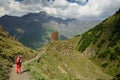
[0,12,99,49]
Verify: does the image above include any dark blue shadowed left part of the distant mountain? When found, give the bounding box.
[0,15,48,48]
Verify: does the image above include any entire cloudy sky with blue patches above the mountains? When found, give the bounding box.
[0,0,120,19]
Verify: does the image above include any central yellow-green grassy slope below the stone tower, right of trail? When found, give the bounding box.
[27,37,111,80]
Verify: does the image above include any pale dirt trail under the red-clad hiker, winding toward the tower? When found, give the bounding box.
[9,51,44,80]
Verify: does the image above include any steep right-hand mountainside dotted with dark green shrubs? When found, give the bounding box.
[76,10,120,80]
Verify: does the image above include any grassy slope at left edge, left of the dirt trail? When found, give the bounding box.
[0,26,36,80]
